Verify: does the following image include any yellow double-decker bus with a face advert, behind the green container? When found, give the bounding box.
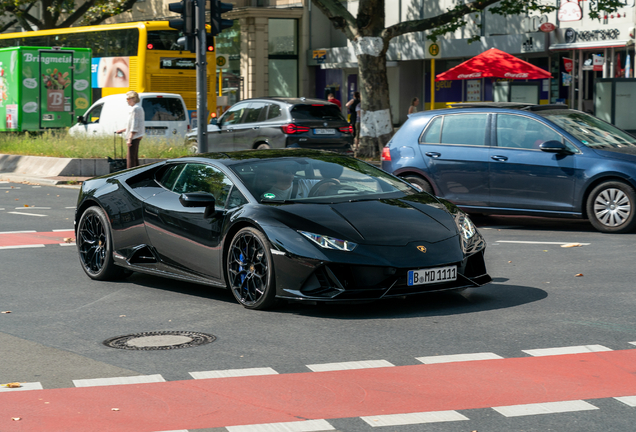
[0,21,216,120]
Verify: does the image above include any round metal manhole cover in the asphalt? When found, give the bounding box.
[103,331,216,351]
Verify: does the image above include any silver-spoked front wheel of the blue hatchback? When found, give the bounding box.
[587,181,636,234]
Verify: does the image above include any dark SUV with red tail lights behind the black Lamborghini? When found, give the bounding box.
[186,97,353,153]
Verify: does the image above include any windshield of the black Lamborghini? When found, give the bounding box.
[230,155,418,203]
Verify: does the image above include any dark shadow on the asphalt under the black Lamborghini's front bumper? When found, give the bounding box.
[277,279,548,320]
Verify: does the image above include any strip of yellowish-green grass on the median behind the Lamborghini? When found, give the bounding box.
[0,132,189,159]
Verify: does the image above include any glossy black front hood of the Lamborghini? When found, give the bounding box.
[266,194,457,246]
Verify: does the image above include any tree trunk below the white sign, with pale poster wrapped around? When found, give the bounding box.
[357,52,393,159]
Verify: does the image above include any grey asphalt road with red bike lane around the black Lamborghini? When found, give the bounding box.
[0,183,636,432]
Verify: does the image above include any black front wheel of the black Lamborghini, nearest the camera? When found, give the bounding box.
[227,227,276,310]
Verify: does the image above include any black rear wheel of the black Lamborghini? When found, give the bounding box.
[76,206,130,280]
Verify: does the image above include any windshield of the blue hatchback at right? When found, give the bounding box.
[537,110,636,149]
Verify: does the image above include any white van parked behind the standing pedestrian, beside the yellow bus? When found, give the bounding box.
[68,93,190,144]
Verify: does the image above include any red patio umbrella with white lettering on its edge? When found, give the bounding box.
[435,48,552,81]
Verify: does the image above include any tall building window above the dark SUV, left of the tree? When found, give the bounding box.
[268,18,298,97]
